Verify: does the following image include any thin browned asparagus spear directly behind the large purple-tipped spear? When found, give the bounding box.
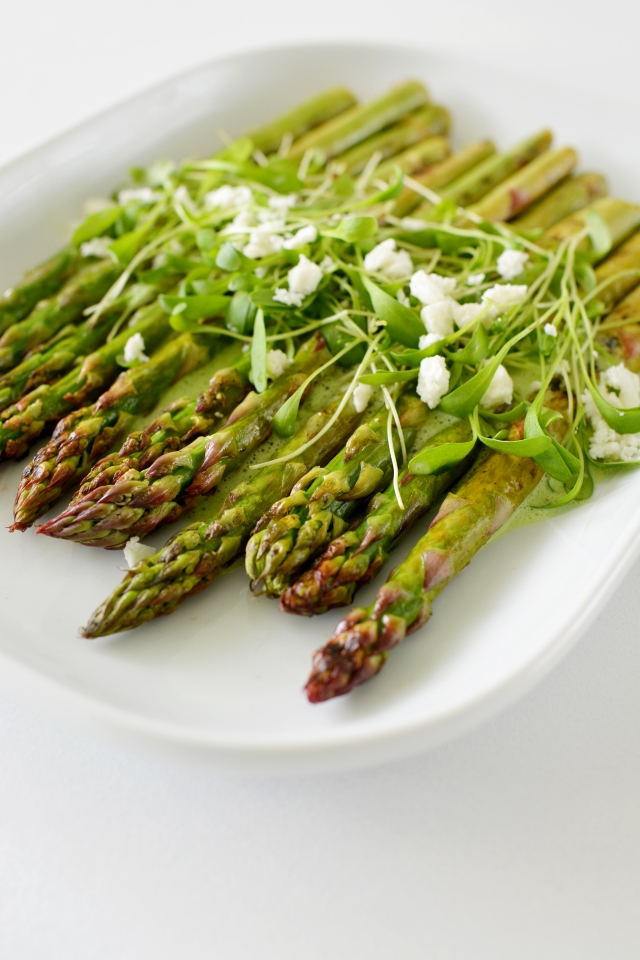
[71,353,251,503]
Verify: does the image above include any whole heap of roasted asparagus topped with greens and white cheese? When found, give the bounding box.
[5,73,640,702]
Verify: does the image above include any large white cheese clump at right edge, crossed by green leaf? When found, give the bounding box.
[582,363,640,463]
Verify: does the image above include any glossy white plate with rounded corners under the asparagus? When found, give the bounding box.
[0,44,640,772]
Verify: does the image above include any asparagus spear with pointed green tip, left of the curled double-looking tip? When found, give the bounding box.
[82,390,368,637]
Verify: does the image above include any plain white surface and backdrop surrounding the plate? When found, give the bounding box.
[0,0,640,960]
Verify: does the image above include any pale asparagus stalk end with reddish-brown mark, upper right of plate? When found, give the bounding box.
[468,147,578,221]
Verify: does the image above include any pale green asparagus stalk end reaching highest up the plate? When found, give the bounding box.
[289,80,429,163]
